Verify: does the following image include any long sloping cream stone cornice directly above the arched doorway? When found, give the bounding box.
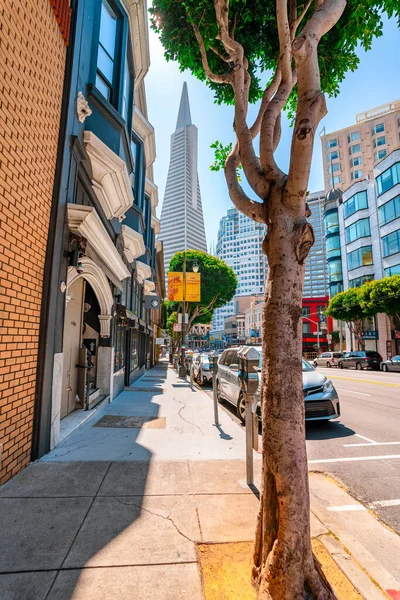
[67,203,130,281]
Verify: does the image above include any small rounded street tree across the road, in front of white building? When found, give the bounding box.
[325,284,375,348]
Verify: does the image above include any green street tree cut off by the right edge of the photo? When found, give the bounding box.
[359,275,400,329]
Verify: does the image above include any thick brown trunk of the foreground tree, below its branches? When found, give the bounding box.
[253,190,335,600]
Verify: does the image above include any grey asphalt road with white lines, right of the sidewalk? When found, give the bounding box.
[203,367,400,534]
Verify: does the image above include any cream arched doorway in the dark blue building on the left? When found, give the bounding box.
[60,257,113,419]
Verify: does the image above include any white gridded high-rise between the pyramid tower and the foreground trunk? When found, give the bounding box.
[213,208,268,330]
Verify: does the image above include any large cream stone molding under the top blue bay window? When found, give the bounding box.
[83,131,133,220]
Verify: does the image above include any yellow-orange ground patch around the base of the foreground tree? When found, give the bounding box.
[197,539,363,600]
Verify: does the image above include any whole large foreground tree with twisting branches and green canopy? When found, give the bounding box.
[151,0,400,600]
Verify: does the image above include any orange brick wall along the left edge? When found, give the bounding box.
[0,0,66,484]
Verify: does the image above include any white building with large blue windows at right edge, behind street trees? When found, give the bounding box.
[337,150,400,358]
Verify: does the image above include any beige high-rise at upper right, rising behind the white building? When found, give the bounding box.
[321,100,400,193]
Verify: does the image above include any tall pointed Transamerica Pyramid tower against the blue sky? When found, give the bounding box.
[158,82,207,273]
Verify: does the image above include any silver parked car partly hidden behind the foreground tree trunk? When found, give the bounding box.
[216,346,340,422]
